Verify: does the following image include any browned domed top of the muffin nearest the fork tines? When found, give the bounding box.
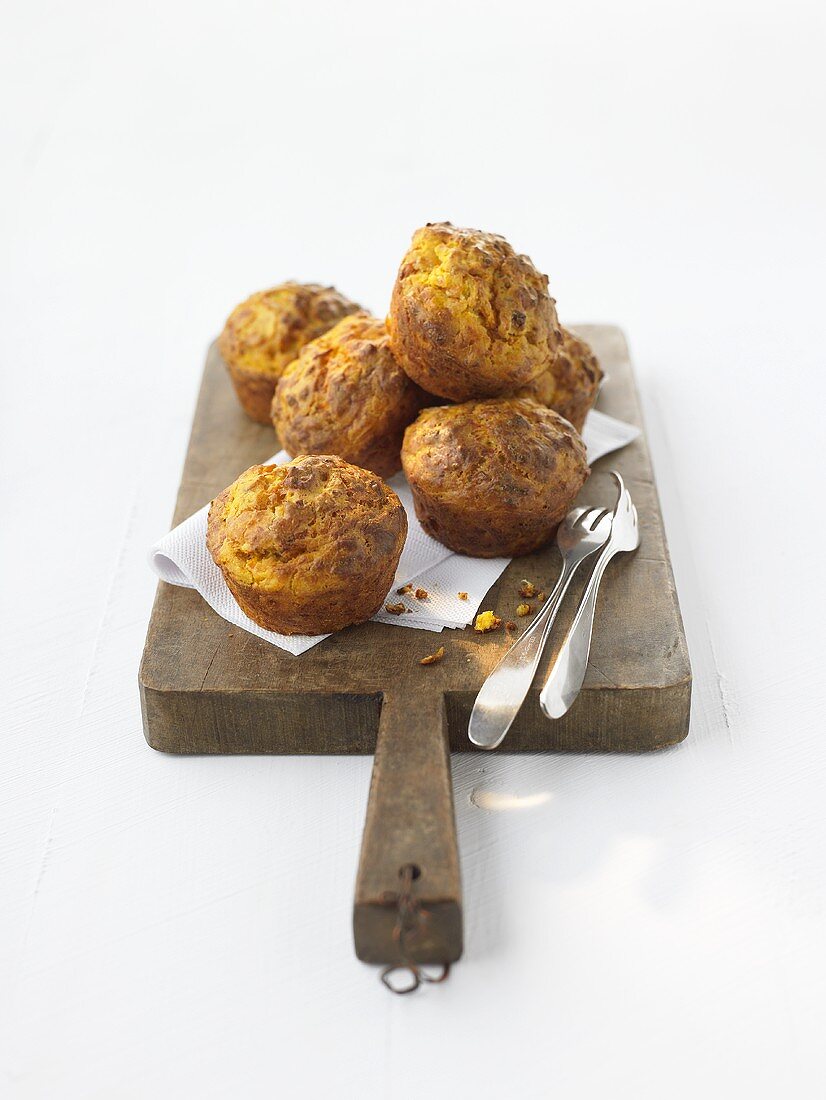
[401,397,588,508]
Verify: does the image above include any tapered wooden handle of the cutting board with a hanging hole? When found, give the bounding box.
[353,693,462,964]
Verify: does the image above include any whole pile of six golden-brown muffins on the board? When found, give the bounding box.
[208,222,602,634]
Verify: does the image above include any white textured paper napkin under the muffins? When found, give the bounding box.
[150,409,639,655]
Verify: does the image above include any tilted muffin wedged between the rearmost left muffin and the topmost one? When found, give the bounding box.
[272,312,432,477]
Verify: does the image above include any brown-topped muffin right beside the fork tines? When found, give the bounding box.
[401,397,590,558]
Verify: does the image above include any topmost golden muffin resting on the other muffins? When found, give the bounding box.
[387,221,560,402]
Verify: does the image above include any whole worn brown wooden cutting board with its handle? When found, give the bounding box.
[140,325,691,963]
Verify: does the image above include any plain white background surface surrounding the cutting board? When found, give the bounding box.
[0,0,826,1100]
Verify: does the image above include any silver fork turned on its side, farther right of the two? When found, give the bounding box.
[539,470,639,718]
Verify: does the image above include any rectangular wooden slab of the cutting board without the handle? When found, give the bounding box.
[140,326,691,754]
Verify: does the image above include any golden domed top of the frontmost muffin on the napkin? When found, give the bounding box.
[207,454,407,594]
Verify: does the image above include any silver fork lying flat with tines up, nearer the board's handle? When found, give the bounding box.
[467,508,612,749]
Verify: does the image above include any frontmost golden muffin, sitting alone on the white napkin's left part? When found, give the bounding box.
[207,454,407,634]
